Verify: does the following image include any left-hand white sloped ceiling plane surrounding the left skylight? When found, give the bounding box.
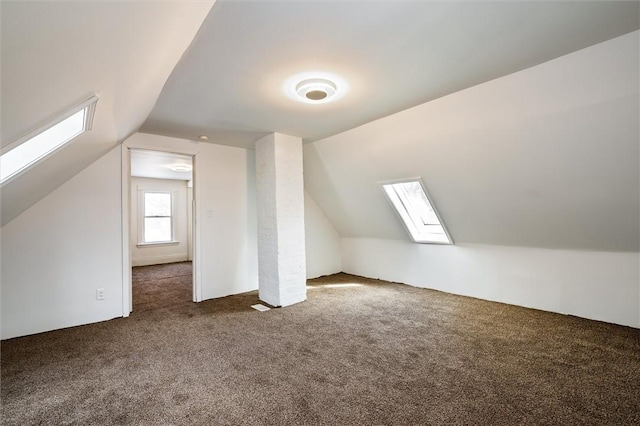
[0,1,213,225]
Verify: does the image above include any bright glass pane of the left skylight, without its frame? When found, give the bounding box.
[0,108,87,181]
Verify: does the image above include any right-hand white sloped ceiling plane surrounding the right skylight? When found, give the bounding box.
[304,31,640,252]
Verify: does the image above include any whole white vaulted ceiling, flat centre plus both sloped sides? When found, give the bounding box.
[0,0,640,250]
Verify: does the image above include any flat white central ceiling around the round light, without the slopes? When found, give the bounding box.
[141,0,639,147]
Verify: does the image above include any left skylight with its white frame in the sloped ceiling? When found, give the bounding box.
[0,96,98,184]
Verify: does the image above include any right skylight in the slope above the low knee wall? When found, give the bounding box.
[382,179,452,244]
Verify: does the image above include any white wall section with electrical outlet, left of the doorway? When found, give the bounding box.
[1,147,122,339]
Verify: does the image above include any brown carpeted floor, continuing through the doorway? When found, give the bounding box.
[1,264,640,425]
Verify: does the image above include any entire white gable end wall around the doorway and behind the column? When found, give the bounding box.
[0,130,340,339]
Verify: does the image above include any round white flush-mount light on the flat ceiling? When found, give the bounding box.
[285,72,346,104]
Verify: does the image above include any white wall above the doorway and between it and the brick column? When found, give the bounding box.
[123,133,258,300]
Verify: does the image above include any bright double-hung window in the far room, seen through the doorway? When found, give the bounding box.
[142,192,173,243]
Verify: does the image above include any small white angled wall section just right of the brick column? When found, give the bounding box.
[304,191,342,278]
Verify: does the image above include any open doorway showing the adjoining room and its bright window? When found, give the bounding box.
[127,148,197,312]
